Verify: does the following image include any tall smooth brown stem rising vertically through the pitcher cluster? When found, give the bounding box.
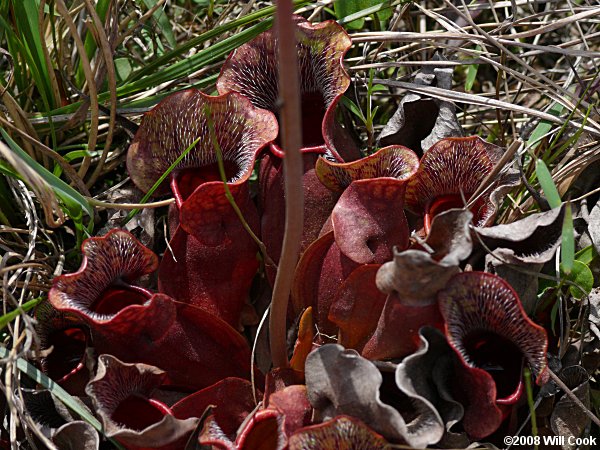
[269,0,304,367]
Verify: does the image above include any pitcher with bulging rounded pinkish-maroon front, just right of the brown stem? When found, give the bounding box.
[292,147,418,336]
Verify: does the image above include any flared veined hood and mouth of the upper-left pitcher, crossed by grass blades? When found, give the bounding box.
[127,89,278,198]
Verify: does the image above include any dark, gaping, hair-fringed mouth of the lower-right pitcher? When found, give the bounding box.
[438,272,548,404]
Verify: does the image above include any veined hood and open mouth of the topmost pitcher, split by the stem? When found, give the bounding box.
[217,16,352,160]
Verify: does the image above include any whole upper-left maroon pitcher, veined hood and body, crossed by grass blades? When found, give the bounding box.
[128,89,278,327]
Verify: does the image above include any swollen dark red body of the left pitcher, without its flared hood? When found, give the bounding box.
[94,294,250,389]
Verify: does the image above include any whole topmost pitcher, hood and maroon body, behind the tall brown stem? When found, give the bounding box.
[217,16,360,283]
